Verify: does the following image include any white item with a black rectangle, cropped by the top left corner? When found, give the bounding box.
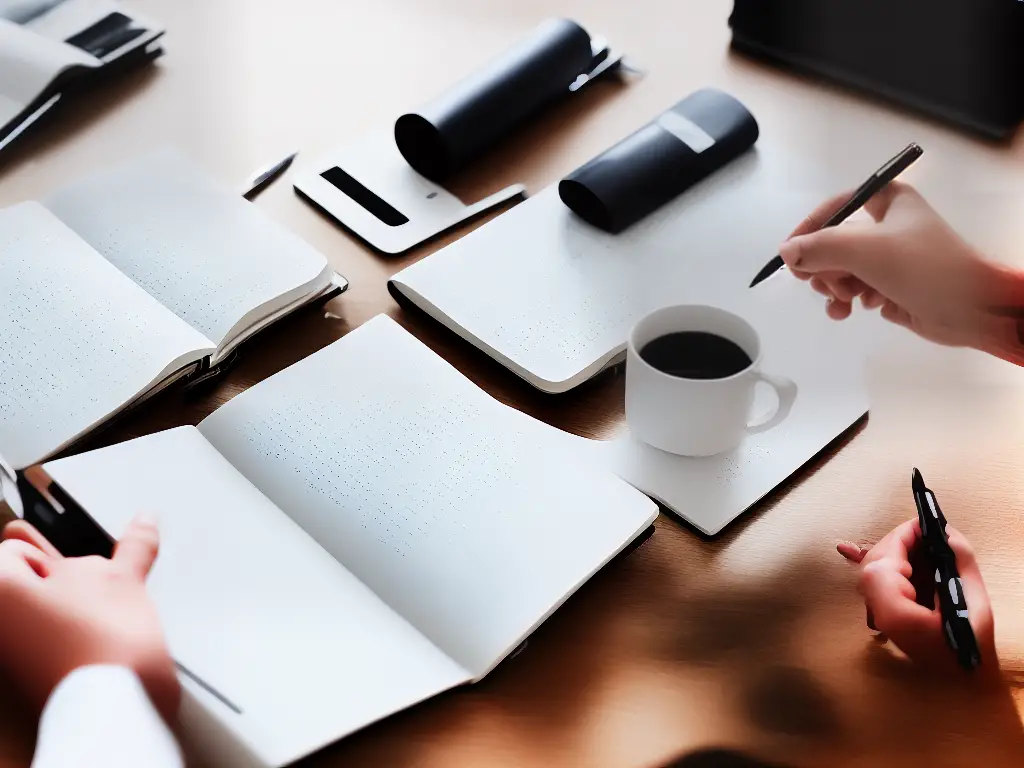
[0,0,164,150]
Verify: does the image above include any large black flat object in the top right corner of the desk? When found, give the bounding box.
[729,0,1024,139]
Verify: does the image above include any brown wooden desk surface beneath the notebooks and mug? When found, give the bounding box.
[0,0,1024,768]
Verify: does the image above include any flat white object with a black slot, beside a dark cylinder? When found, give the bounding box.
[295,125,525,254]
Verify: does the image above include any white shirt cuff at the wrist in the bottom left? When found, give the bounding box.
[32,666,184,768]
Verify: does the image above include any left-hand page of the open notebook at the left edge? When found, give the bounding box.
[0,203,213,467]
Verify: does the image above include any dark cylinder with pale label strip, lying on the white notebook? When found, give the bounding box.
[558,88,760,233]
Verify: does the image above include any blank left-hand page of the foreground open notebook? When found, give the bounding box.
[46,427,468,765]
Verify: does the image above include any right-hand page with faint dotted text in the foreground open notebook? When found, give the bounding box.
[200,315,655,677]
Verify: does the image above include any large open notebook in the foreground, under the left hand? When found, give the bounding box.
[8,315,656,766]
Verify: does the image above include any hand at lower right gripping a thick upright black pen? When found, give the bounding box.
[837,519,998,673]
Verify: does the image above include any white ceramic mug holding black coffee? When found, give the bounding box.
[626,305,797,457]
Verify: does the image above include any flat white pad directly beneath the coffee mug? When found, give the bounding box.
[584,272,884,536]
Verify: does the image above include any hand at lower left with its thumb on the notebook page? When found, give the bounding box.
[0,520,181,723]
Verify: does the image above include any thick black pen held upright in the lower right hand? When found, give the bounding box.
[910,468,981,670]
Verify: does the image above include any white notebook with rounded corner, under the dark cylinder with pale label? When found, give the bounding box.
[393,147,833,391]
